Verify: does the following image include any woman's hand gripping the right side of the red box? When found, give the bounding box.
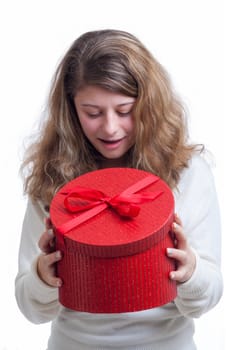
[167,215,196,283]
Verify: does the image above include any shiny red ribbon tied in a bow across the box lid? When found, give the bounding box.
[57,175,163,235]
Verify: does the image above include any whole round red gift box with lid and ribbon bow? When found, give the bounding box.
[50,168,177,313]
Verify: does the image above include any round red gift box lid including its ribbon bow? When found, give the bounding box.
[50,168,174,257]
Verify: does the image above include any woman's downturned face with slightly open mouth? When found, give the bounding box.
[74,86,136,166]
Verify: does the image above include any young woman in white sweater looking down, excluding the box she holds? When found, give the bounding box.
[16,30,222,350]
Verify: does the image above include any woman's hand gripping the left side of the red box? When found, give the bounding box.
[37,219,62,287]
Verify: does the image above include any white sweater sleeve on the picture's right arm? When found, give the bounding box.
[175,157,223,317]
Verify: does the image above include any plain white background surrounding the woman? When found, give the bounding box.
[0,0,230,350]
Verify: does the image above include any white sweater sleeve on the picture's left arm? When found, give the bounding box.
[15,200,60,323]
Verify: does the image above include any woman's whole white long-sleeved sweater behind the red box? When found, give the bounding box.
[16,156,222,350]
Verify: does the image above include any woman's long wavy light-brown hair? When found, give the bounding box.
[22,30,201,204]
